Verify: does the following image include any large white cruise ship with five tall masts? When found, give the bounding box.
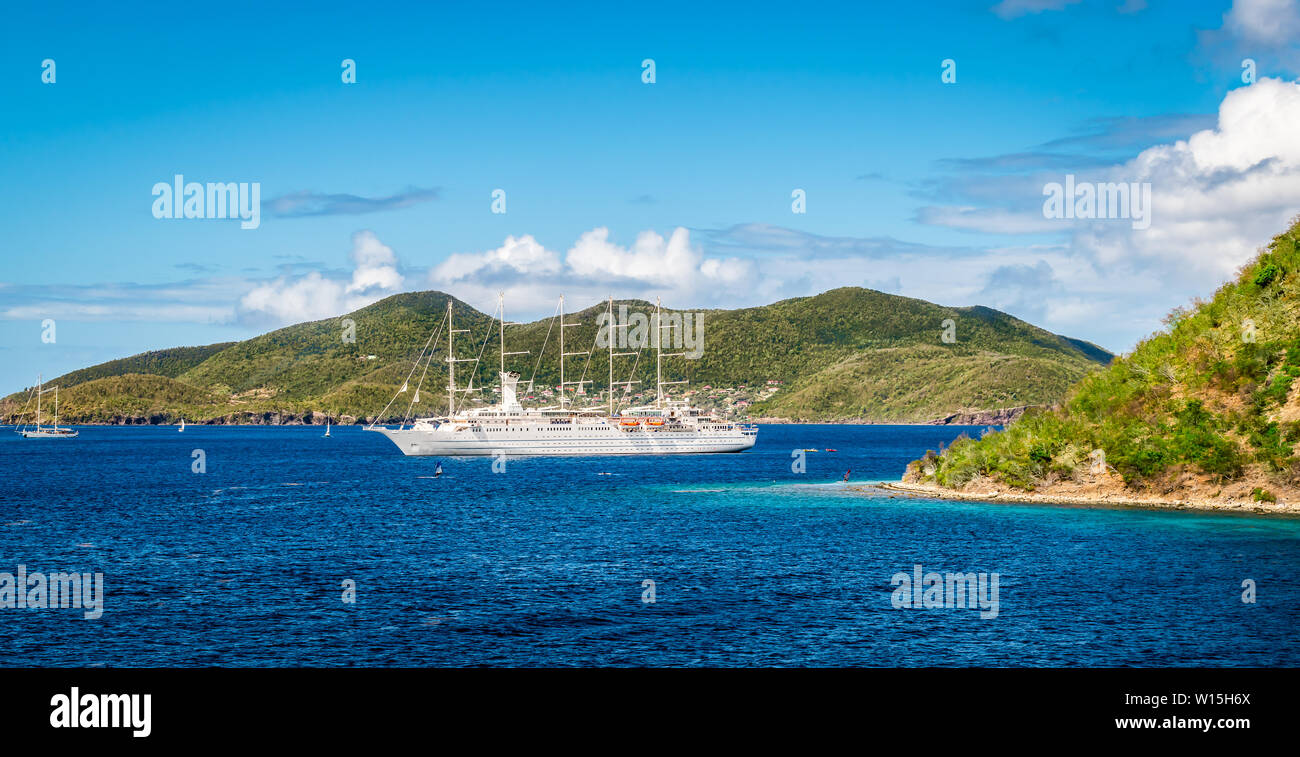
[369,298,758,457]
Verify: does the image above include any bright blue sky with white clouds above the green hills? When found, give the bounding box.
[0,0,1300,392]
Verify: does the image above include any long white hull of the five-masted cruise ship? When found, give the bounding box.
[374,428,757,457]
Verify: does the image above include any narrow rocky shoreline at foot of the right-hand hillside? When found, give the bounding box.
[854,481,1300,516]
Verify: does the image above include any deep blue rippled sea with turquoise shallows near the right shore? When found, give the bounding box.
[0,425,1300,667]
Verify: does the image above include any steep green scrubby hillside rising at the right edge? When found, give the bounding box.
[907,222,1300,499]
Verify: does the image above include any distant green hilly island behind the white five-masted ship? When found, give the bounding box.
[0,287,1110,423]
